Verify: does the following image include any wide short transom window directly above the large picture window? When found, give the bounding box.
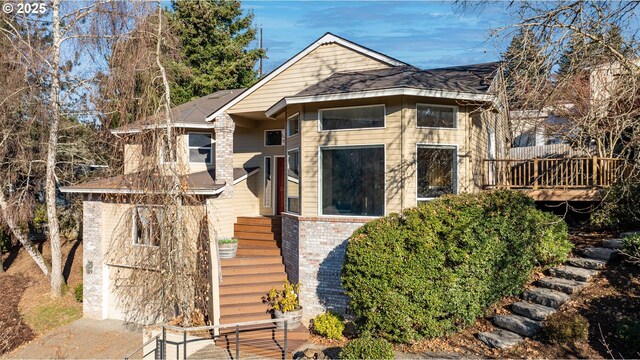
[318,105,385,131]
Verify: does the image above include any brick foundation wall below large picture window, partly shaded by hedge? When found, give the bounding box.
[282,215,369,322]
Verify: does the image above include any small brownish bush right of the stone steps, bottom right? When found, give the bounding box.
[544,312,589,344]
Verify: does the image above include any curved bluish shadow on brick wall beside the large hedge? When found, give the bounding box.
[316,239,349,314]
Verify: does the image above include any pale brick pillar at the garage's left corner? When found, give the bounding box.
[82,196,108,319]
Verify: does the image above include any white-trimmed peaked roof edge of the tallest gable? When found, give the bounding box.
[202,32,408,121]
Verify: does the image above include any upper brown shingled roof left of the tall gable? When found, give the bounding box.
[111,89,246,134]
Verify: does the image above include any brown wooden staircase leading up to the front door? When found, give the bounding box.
[216,216,309,358]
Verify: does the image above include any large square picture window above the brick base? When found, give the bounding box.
[321,145,385,216]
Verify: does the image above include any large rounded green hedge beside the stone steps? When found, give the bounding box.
[342,191,572,343]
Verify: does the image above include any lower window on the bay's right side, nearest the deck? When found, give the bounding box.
[417,145,458,201]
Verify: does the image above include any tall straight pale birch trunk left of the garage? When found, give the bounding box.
[45,0,64,297]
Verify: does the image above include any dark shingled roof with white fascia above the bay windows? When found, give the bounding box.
[266,62,500,116]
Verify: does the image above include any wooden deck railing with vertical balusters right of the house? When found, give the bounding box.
[482,157,625,190]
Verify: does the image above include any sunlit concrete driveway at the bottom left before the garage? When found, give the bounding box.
[5,319,142,359]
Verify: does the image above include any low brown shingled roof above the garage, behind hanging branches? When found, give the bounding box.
[60,167,258,195]
